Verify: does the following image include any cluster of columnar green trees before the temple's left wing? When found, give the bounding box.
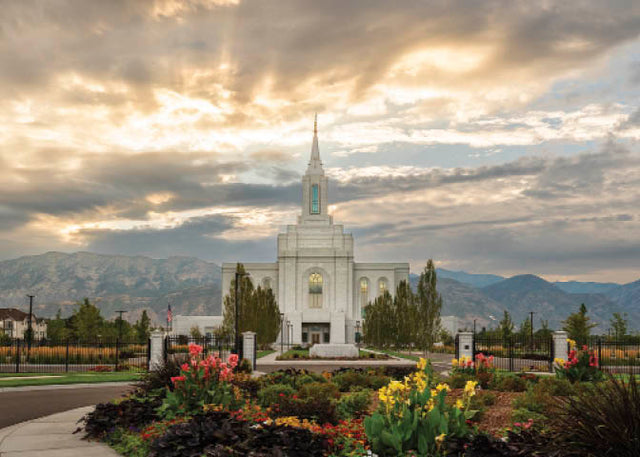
[223,263,281,347]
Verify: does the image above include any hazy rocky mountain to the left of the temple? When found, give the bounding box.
[0,252,221,323]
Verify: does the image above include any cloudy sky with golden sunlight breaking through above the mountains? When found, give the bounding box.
[0,0,640,283]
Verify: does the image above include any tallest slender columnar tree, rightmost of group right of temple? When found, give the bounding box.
[415,259,442,352]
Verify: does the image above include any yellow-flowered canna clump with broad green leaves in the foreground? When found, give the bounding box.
[364,359,476,456]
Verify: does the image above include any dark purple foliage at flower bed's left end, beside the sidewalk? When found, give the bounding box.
[82,397,162,438]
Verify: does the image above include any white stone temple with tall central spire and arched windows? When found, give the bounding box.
[222,118,409,344]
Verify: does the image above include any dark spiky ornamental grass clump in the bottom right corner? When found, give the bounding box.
[557,375,640,457]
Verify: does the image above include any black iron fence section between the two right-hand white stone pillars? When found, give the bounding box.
[473,335,554,372]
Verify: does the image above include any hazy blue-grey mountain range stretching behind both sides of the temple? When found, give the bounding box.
[0,252,640,332]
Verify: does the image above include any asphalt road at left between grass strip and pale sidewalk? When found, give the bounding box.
[0,382,131,430]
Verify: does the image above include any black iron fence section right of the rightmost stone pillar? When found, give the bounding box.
[586,337,640,375]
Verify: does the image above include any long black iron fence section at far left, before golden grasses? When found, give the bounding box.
[0,338,149,373]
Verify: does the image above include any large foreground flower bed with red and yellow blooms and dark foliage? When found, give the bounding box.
[85,345,640,457]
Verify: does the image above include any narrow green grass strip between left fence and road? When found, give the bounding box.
[0,371,141,388]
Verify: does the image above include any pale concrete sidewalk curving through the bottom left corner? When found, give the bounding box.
[0,406,118,457]
